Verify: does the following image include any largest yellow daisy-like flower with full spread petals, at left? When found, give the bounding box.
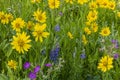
[11,32,31,53]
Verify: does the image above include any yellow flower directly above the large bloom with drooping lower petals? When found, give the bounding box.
[33,10,46,23]
